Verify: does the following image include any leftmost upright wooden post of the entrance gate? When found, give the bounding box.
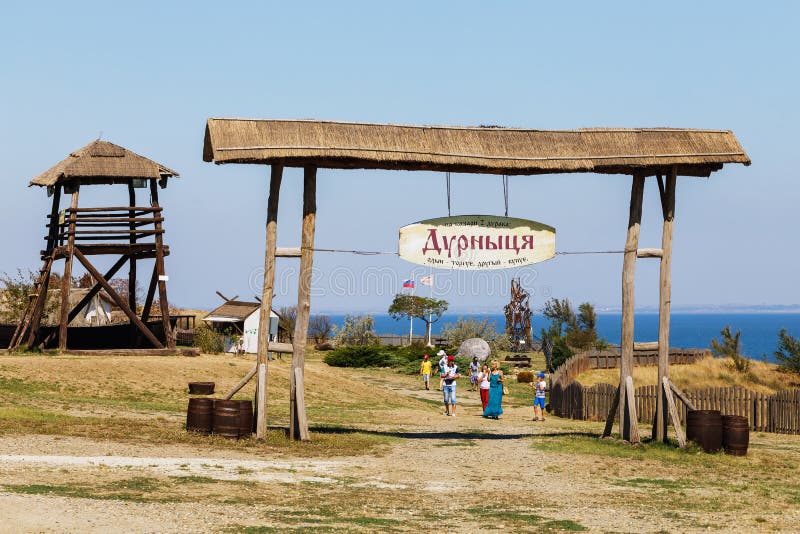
[255,164,283,439]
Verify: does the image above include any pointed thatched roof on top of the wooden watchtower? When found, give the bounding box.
[30,139,178,186]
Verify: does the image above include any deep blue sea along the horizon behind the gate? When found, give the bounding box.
[330,312,800,362]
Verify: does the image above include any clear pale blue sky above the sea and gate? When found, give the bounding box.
[0,1,800,311]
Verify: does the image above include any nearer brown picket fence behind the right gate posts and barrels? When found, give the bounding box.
[550,381,800,434]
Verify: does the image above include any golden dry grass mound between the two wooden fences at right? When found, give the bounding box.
[576,358,800,394]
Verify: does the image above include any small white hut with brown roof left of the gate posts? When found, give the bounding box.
[203,300,280,354]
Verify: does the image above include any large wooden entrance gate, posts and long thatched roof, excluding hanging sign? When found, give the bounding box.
[203,119,750,442]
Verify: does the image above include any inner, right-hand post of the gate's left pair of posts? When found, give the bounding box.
[289,167,317,440]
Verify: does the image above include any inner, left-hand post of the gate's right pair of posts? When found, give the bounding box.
[619,175,644,442]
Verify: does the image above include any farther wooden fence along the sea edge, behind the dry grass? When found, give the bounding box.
[551,348,711,386]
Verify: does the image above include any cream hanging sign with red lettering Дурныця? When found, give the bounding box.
[399,215,556,270]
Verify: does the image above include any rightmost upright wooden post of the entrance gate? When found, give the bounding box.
[653,166,678,441]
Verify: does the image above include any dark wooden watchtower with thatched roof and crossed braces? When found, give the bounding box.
[9,140,178,350]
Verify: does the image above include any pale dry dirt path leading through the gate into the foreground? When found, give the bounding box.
[0,376,800,532]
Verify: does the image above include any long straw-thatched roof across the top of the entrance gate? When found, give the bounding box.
[203,119,750,176]
